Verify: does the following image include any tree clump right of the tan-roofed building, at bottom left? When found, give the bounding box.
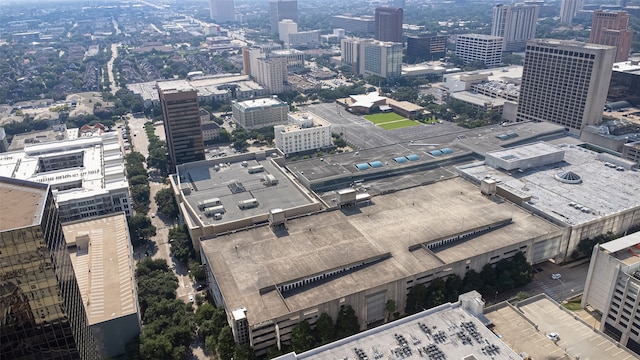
[127,258,196,360]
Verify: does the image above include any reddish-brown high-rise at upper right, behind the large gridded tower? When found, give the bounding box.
[589,10,633,62]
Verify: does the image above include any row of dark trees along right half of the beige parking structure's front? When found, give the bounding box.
[405,252,533,314]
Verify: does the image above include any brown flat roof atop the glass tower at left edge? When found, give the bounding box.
[0,176,49,231]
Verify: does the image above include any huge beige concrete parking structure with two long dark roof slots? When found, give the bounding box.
[201,178,568,354]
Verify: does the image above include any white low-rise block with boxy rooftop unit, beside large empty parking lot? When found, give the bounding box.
[273,112,331,155]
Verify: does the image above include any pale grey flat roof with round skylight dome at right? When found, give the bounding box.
[459,144,640,225]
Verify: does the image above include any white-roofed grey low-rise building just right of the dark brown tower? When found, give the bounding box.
[231,96,289,130]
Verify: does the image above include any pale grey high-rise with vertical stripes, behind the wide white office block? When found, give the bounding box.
[491,4,540,51]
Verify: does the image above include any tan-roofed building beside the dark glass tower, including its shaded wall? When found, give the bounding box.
[62,213,142,358]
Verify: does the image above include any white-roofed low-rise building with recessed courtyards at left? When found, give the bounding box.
[0,132,132,222]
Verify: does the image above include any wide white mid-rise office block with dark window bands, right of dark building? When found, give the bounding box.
[456,34,502,68]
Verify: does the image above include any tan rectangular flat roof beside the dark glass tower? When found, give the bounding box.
[62,213,138,325]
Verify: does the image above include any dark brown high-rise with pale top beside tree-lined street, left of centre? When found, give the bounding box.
[158,80,204,169]
